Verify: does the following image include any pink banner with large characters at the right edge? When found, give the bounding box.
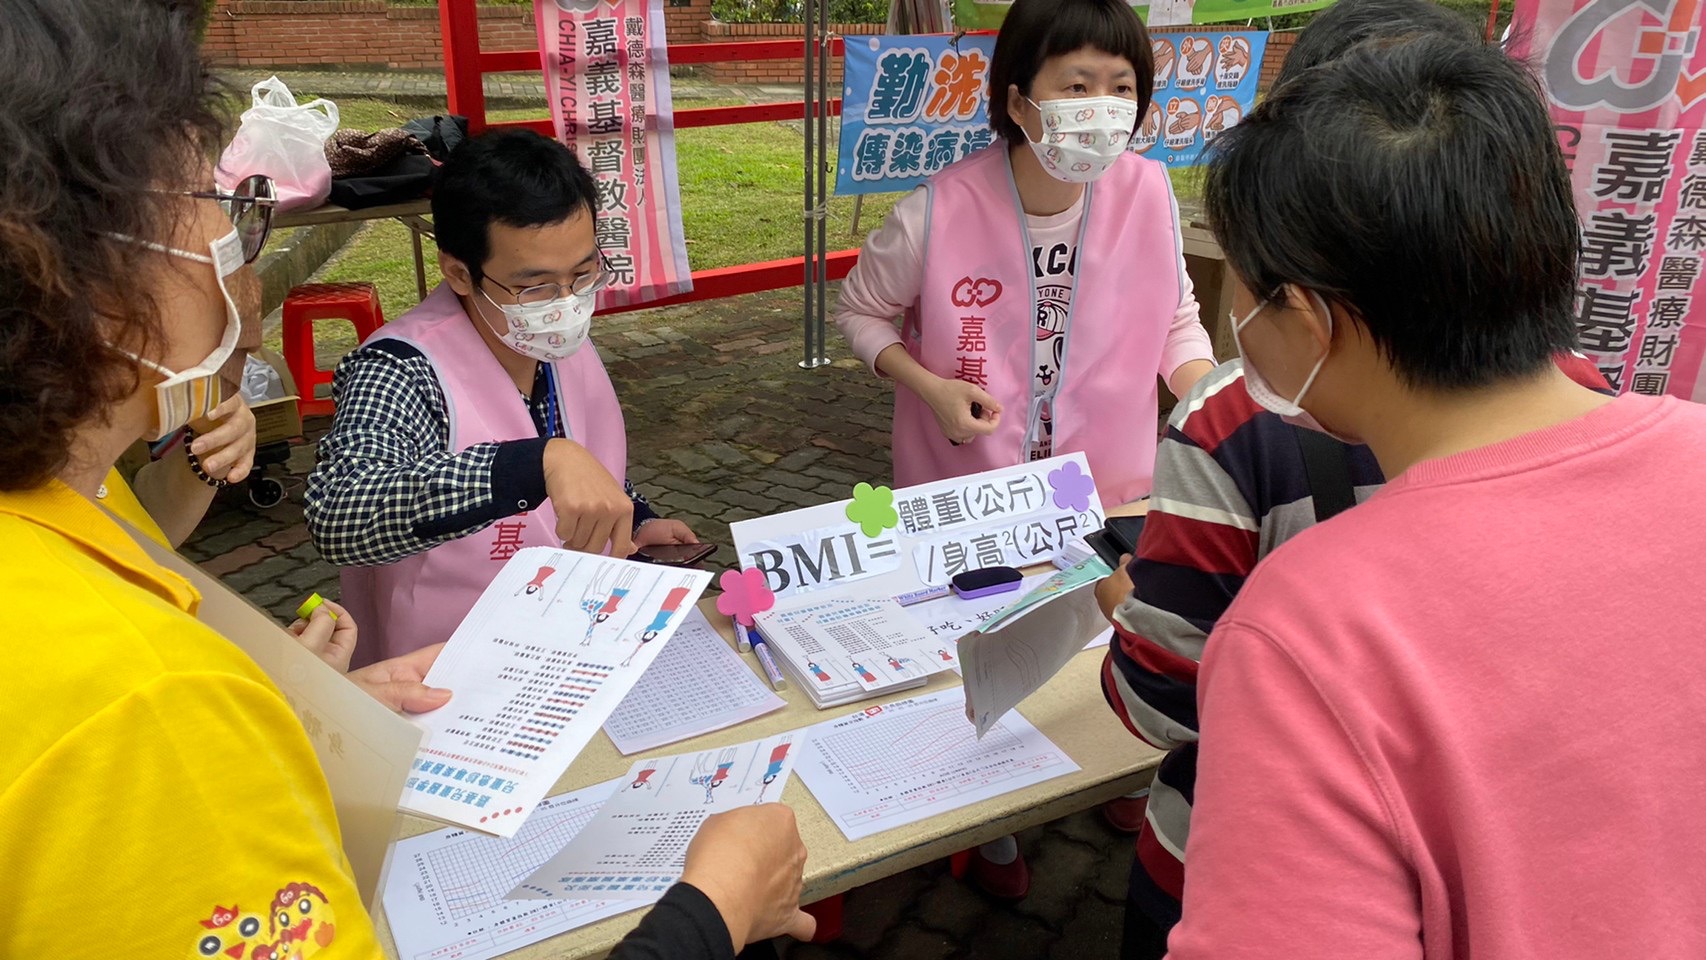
[1512,0,1706,401]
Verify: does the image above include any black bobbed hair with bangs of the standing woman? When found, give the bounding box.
[989,0,1155,143]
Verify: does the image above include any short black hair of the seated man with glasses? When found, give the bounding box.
[432,130,599,283]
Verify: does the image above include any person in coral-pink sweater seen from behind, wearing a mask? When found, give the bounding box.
[1169,36,1706,960]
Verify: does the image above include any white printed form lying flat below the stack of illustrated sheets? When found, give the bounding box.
[800,687,1078,841]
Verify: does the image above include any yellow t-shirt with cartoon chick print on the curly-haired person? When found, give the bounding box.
[0,483,380,960]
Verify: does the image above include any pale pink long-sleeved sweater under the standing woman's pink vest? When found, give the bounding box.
[834,188,1215,380]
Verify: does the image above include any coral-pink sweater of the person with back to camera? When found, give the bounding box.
[1170,396,1706,960]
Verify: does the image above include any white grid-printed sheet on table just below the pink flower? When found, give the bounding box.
[604,609,786,757]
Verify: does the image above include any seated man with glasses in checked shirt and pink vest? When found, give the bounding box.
[307,131,696,665]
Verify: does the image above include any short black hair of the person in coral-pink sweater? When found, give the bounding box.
[1203,36,1576,390]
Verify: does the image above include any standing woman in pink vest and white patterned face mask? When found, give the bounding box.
[836,0,1213,506]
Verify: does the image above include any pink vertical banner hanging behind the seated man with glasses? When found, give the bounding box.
[534,0,693,309]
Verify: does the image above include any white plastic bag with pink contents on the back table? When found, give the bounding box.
[213,77,338,210]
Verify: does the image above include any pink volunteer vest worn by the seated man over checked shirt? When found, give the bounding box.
[341,283,628,667]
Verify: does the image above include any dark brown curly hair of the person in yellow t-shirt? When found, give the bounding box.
[0,0,225,491]
